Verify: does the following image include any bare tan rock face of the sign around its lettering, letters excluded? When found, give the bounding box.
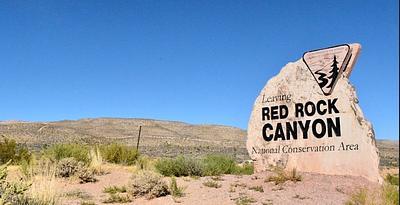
[247,56,382,182]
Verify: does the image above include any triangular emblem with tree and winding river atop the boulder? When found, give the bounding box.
[303,44,351,95]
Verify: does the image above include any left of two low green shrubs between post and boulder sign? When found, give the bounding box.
[155,156,203,177]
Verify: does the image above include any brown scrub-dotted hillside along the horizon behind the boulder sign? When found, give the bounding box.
[0,118,399,166]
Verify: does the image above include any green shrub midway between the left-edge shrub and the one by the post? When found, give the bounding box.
[44,144,90,164]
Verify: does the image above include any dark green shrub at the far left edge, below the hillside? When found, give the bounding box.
[0,136,32,164]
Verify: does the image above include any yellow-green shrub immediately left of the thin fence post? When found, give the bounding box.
[100,143,139,165]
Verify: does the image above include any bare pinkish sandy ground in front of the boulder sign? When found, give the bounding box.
[59,169,379,205]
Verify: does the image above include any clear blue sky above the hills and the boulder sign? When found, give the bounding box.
[0,0,399,139]
